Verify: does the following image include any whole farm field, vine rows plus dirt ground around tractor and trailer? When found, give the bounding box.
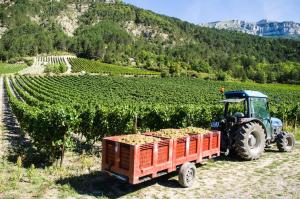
[0,75,300,198]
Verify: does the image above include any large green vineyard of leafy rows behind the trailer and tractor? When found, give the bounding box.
[4,75,300,162]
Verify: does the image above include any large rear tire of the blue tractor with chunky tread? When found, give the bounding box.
[235,122,266,160]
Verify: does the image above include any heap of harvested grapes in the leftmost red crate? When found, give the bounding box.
[119,134,160,145]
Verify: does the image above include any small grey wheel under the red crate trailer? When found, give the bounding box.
[178,162,196,187]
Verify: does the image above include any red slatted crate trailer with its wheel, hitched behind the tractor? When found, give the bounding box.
[102,131,221,187]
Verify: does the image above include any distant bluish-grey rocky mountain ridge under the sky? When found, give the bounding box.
[200,19,300,39]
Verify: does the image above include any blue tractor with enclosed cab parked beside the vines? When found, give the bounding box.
[212,90,295,160]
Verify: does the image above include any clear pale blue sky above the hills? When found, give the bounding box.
[124,0,300,23]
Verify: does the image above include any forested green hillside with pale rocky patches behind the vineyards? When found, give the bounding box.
[0,0,300,82]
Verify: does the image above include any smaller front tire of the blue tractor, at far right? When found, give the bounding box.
[276,132,295,152]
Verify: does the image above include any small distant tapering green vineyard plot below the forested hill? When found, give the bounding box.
[69,58,159,75]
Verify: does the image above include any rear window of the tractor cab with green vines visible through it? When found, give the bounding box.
[222,99,248,117]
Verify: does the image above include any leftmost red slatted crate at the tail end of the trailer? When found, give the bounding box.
[102,136,173,184]
